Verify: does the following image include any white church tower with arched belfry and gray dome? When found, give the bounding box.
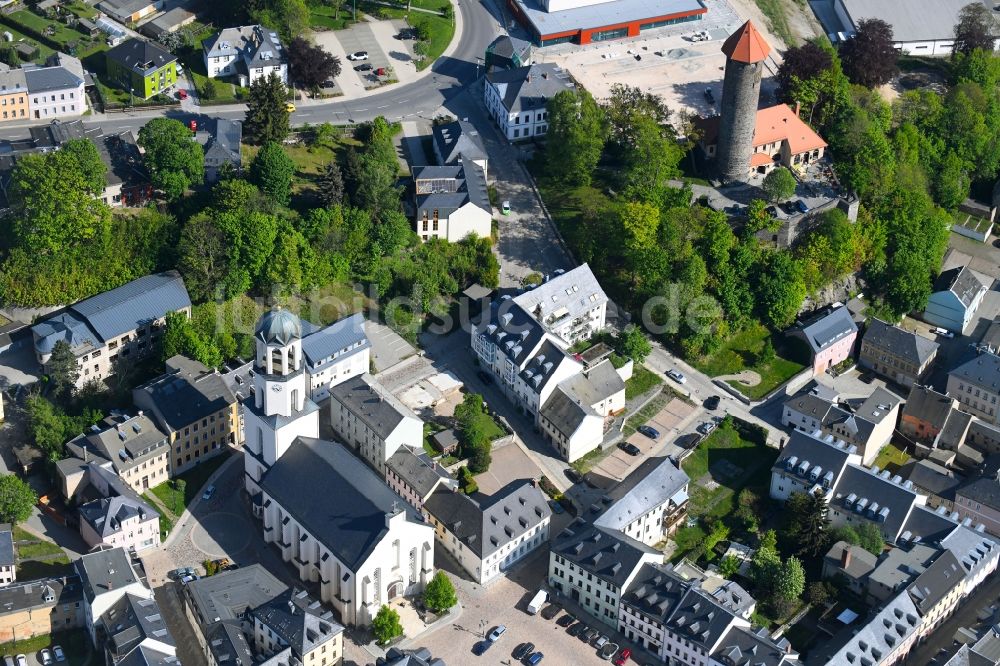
[243,307,319,497]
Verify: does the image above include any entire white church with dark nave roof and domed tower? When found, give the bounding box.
[244,309,434,625]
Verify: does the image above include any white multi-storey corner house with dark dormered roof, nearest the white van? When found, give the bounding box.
[548,517,663,629]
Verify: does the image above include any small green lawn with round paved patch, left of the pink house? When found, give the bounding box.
[692,323,806,400]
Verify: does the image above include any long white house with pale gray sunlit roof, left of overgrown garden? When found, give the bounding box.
[590,457,691,546]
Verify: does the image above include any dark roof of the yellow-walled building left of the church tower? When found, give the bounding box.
[132,355,236,432]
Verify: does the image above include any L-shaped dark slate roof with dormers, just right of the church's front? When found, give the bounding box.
[424,479,552,558]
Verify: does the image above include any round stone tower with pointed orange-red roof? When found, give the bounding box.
[716,21,771,183]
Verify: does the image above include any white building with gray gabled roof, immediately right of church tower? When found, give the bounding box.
[330,374,424,477]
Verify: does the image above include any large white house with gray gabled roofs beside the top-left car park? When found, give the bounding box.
[202,25,288,87]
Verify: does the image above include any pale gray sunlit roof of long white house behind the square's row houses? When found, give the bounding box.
[594,458,691,530]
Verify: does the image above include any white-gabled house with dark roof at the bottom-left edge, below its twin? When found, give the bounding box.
[97,592,180,666]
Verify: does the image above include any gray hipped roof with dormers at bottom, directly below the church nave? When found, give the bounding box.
[252,589,344,659]
